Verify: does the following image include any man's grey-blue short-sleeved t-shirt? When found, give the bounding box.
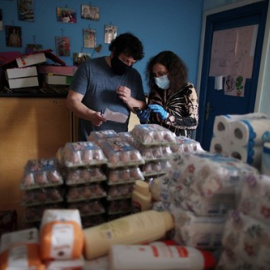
[69,57,145,141]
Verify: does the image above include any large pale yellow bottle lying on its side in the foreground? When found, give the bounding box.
[83,210,174,260]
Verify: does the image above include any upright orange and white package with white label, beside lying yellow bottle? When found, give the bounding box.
[40,209,84,260]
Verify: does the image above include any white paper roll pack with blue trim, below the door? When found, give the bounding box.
[210,113,270,169]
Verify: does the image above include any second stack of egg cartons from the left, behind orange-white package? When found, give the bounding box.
[56,142,107,228]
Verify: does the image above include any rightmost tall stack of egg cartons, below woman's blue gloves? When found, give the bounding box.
[129,124,177,182]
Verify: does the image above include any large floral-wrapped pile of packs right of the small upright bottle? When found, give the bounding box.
[150,152,259,250]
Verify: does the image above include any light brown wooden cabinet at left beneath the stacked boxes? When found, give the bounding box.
[0,97,74,226]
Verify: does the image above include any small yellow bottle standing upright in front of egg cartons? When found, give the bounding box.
[132,180,152,213]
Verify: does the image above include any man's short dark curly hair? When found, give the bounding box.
[109,33,144,60]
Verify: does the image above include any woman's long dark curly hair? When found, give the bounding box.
[146,51,188,92]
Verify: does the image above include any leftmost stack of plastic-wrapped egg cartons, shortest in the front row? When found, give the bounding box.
[20,157,64,228]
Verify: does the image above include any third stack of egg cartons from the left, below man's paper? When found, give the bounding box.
[88,130,144,220]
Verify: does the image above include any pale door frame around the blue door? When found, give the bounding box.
[196,0,270,142]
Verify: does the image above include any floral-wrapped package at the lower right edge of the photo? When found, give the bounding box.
[217,175,270,270]
